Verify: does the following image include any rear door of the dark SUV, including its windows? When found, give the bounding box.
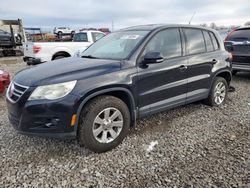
[183,28,218,102]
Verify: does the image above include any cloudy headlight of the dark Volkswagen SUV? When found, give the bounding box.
[28,80,77,100]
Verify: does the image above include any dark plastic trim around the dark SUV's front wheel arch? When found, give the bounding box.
[75,87,137,131]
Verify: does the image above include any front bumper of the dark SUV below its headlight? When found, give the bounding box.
[6,88,77,138]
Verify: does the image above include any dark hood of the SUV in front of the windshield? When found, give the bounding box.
[13,57,121,86]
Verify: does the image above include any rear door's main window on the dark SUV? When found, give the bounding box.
[184,29,206,54]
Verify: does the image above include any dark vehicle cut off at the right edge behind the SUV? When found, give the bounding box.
[224,27,250,74]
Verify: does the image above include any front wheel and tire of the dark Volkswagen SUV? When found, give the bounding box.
[77,95,130,153]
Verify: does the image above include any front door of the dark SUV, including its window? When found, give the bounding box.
[137,28,187,116]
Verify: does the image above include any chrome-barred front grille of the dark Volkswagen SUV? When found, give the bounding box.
[7,82,28,103]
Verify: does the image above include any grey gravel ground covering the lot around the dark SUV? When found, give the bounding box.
[0,59,250,187]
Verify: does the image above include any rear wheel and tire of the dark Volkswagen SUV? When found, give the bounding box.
[205,77,228,106]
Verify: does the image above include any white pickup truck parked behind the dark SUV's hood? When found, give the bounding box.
[23,30,105,65]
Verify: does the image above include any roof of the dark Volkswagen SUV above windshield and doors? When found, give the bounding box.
[120,24,214,31]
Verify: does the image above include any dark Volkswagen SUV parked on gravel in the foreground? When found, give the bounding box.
[6,25,231,152]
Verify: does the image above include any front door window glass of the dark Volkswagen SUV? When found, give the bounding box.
[143,28,182,58]
